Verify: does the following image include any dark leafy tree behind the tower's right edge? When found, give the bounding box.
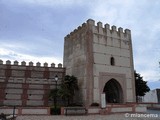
[134,71,150,100]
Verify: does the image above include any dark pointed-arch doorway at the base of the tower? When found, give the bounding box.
[103,79,123,103]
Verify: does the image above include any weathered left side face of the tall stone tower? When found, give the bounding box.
[63,23,87,104]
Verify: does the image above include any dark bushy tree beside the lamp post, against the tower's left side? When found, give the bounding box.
[58,75,79,105]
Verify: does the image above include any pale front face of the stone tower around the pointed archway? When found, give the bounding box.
[89,21,135,102]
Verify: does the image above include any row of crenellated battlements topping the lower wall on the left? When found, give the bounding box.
[0,60,62,68]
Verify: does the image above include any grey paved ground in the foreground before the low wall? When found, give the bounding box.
[16,110,160,120]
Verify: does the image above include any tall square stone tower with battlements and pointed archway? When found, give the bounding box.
[64,19,135,106]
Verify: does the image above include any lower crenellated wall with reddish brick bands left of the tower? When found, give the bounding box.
[0,60,65,106]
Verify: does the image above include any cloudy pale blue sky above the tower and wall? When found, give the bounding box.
[0,0,160,89]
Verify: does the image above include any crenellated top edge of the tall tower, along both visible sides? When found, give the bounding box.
[65,19,131,38]
